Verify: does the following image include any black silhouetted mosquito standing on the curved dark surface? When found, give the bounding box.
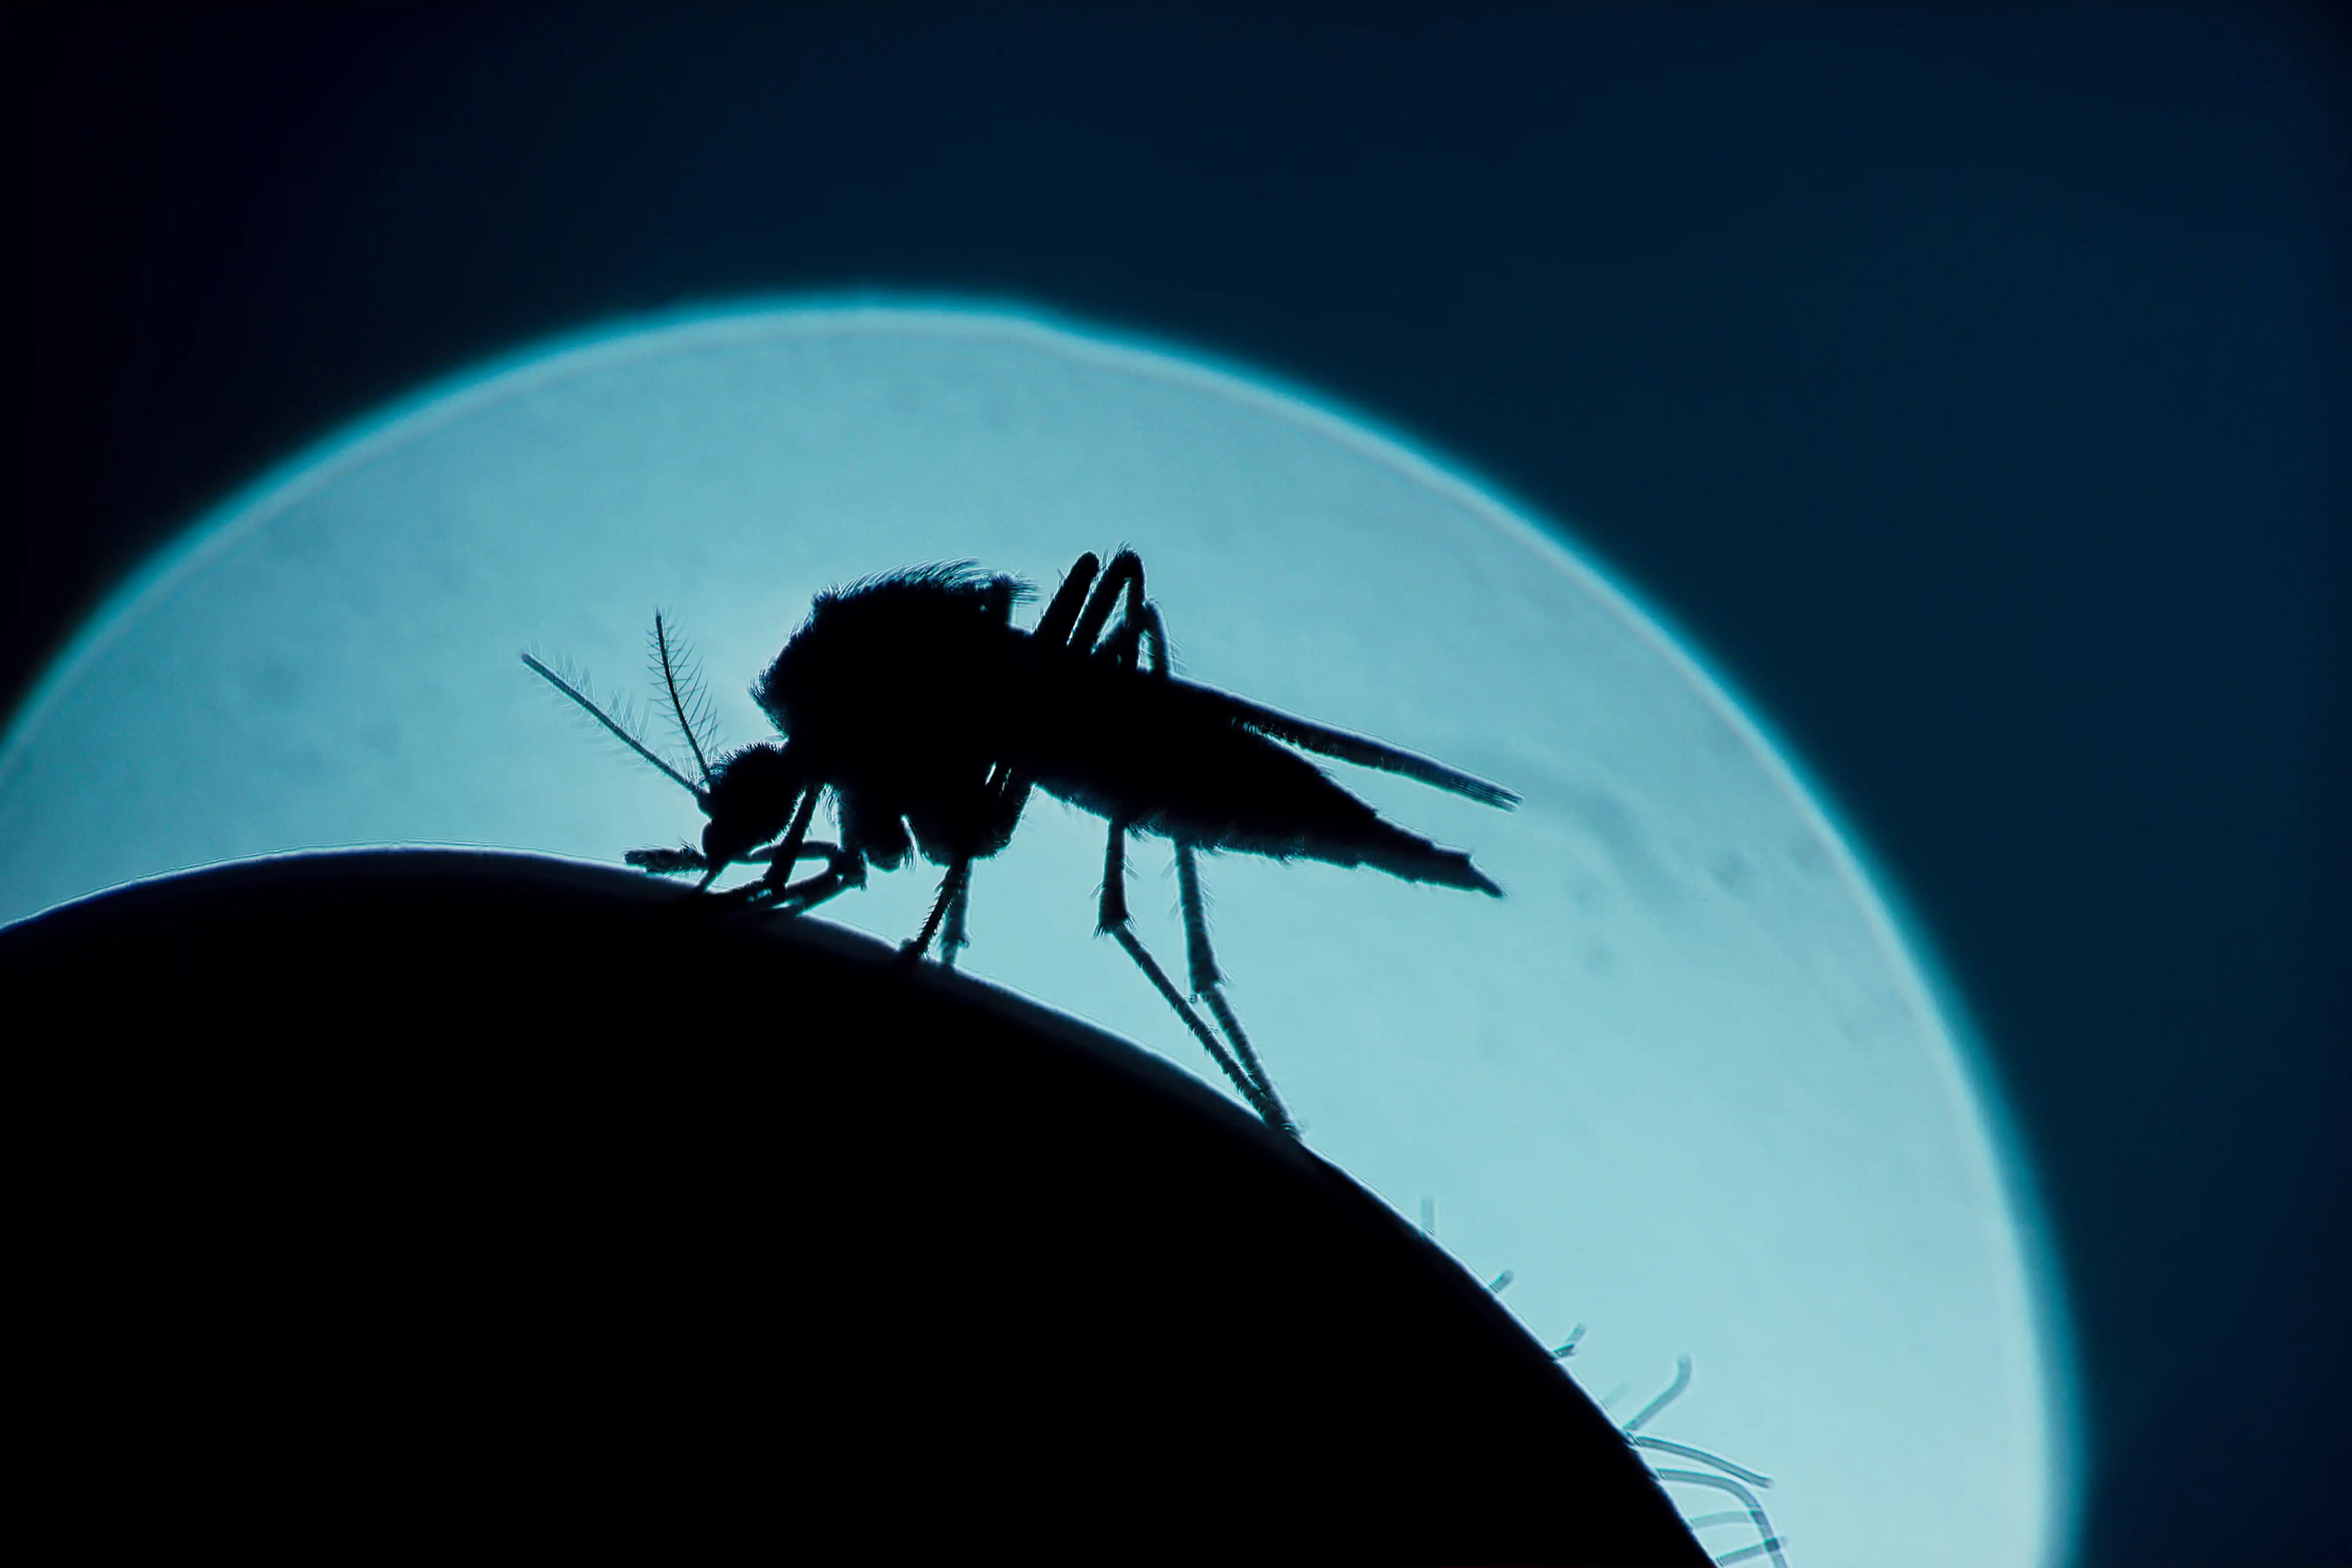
[522,550,1519,1138]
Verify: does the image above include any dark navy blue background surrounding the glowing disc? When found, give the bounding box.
[23,5,2352,1563]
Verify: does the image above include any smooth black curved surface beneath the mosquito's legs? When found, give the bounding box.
[0,851,1707,1563]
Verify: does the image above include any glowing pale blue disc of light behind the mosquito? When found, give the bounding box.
[0,306,2072,1568]
